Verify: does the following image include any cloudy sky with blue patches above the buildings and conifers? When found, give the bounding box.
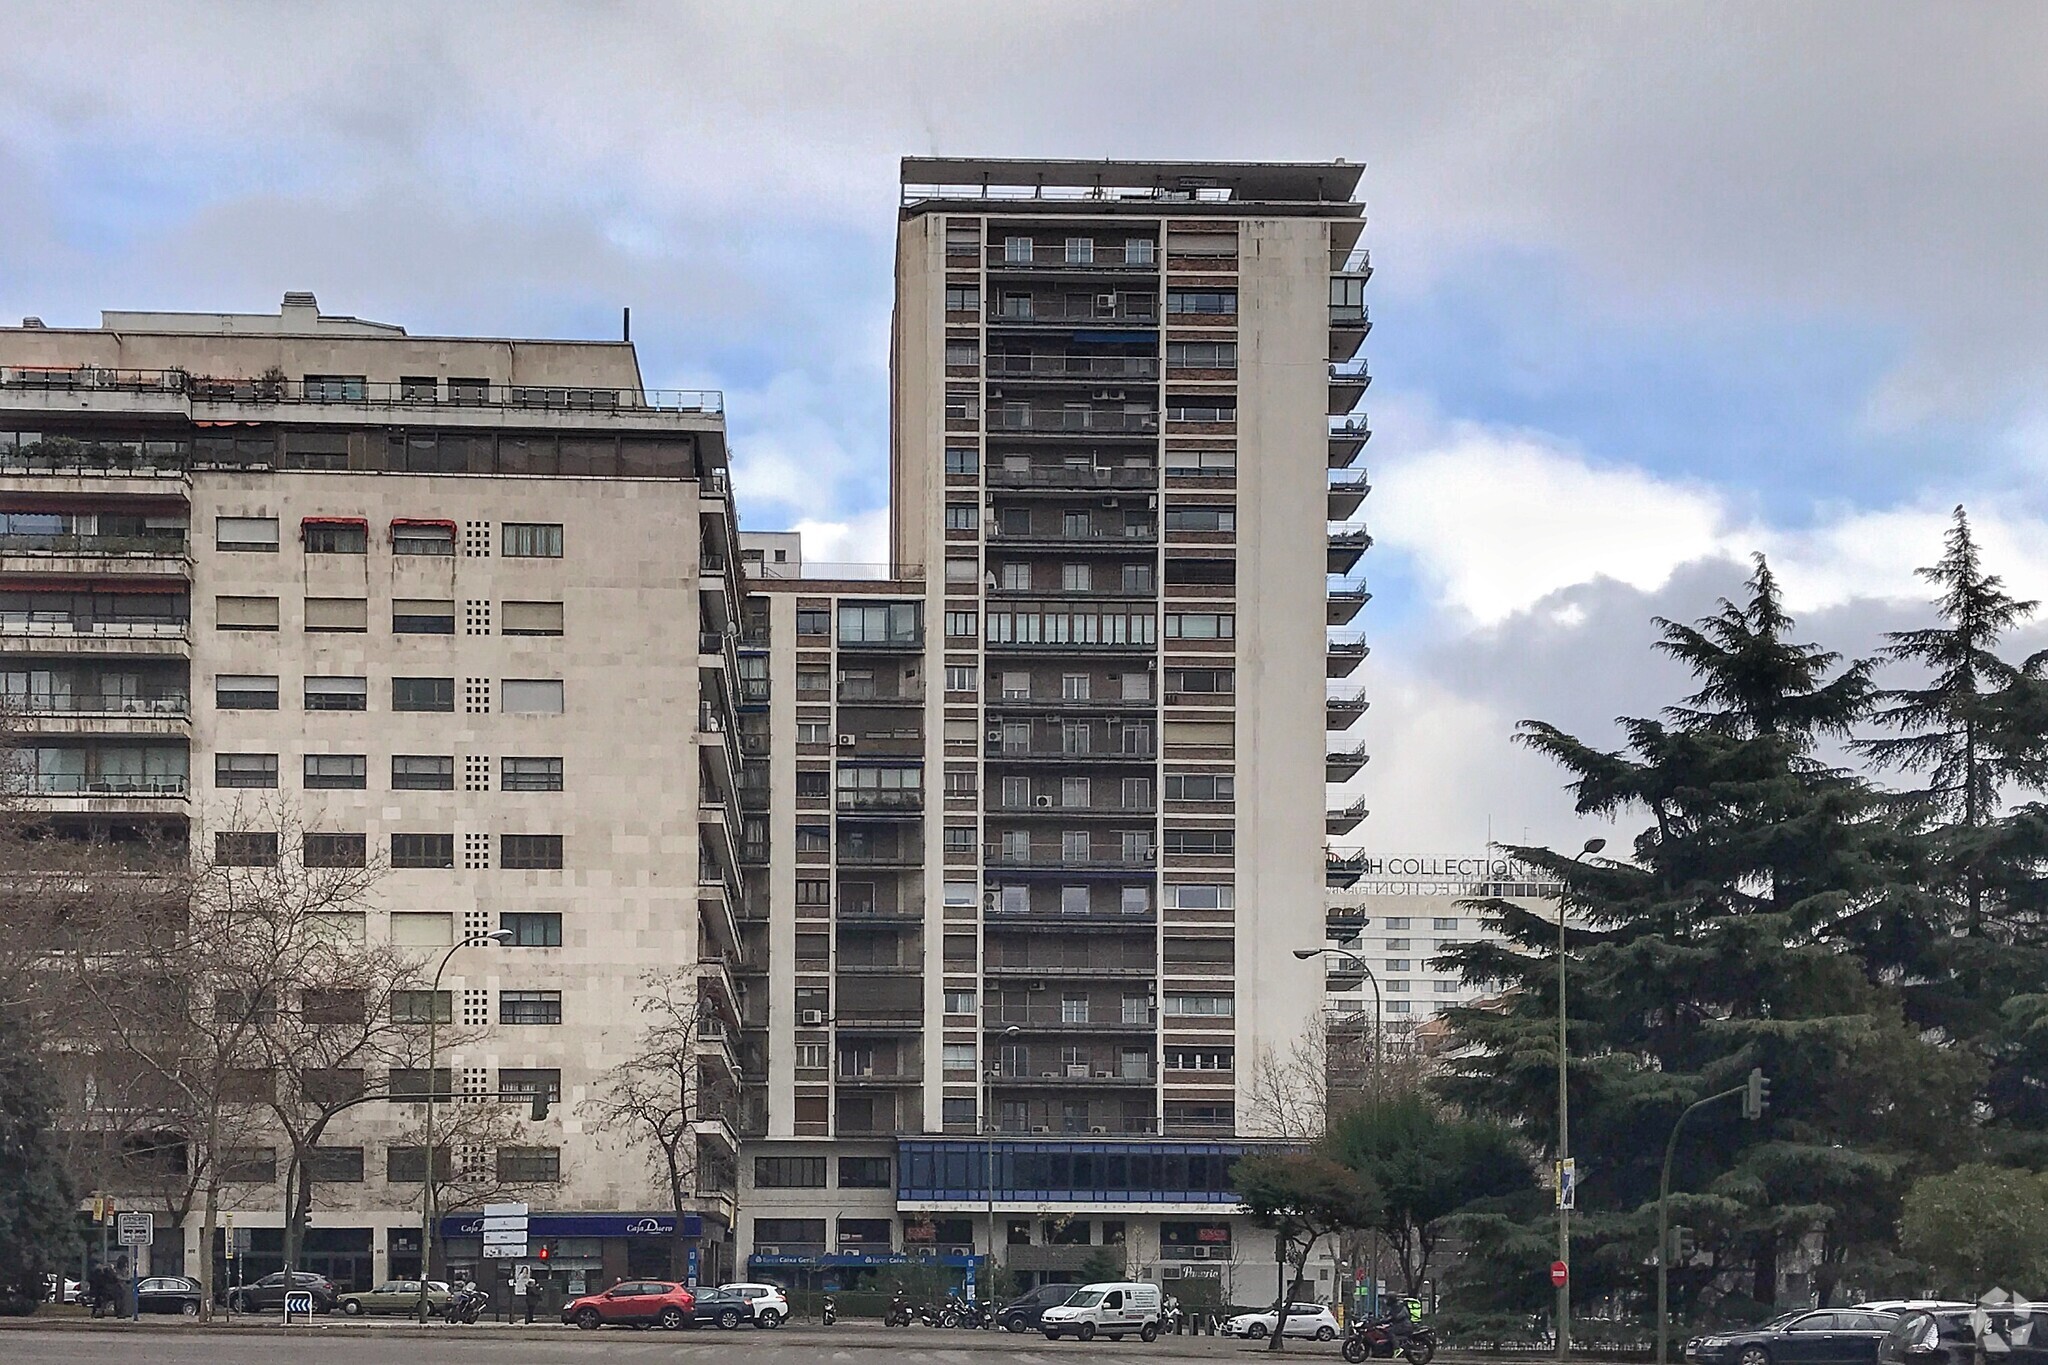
[0,0,2048,855]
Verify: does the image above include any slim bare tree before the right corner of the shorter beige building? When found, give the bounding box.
[590,970,737,1265]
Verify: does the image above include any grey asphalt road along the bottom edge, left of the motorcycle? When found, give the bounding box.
[0,1322,1294,1365]
